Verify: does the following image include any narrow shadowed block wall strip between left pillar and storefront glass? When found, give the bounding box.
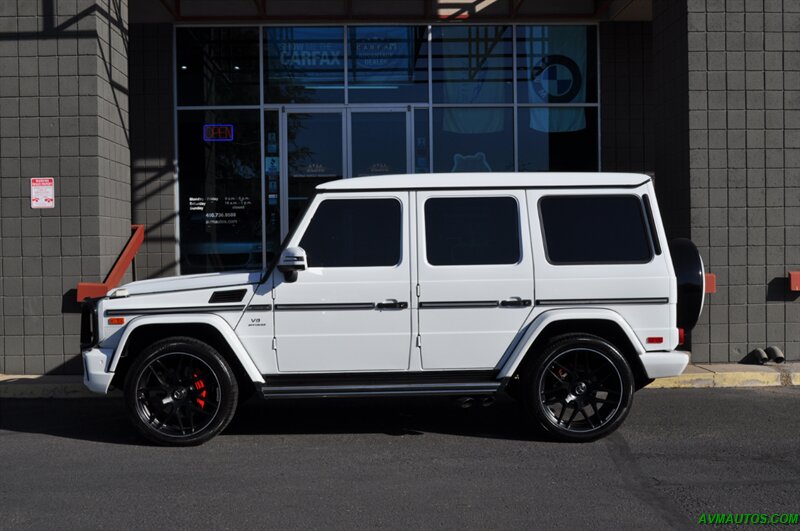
[129,24,177,279]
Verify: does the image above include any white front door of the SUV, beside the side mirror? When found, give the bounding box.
[274,192,411,372]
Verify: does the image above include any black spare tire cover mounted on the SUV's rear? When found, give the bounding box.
[669,238,705,330]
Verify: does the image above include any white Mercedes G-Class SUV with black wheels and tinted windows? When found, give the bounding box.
[81,173,704,445]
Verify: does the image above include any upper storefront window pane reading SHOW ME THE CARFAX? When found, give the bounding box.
[264,27,345,103]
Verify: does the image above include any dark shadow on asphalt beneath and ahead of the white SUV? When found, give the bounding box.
[0,397,548,446]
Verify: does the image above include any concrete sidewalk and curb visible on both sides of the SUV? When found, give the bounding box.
[0,362,800,398]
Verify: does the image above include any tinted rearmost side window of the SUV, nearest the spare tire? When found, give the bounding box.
[539,195,652,264]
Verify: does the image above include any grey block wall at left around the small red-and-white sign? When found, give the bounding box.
[0,0,130,374]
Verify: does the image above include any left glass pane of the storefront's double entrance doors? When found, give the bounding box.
[281,108,347,236]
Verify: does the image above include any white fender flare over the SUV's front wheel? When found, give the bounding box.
[108,313,264,383]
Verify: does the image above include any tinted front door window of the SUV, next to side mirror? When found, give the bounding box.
[300,199,403,267]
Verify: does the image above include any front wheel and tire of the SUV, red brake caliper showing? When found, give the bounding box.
[125,337,239,446]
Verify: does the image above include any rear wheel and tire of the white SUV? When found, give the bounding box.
[522,334,634,442]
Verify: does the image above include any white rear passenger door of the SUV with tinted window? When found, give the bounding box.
[416,190,534,370]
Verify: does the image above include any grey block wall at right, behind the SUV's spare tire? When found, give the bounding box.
[687,0,800,362]
